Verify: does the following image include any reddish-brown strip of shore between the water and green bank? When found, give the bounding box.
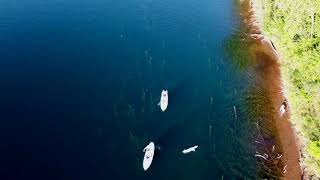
[240,0,303,180]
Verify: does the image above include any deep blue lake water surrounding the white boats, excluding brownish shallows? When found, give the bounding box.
[0,0,256,180]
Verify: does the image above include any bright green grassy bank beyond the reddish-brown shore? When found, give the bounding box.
[254,0,320,177]
